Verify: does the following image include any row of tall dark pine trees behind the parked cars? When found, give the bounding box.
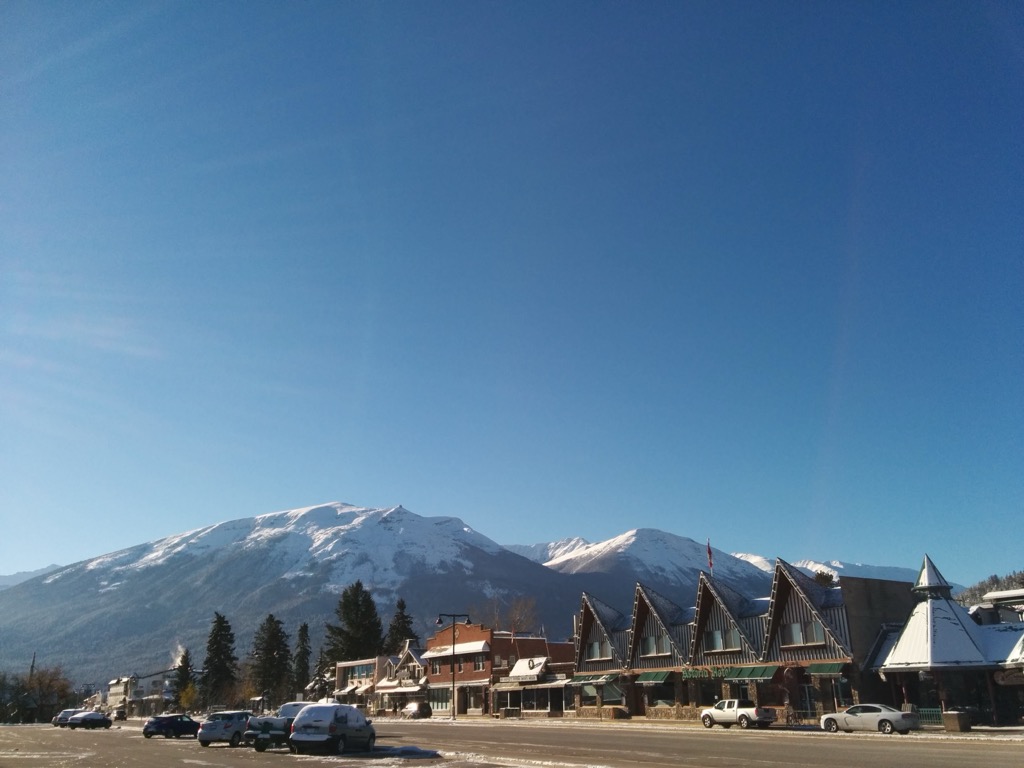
[173,582,419,710]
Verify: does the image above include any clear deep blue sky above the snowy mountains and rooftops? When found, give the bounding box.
[0,0,1024,584]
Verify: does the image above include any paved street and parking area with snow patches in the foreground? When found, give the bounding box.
[0,720,1024,768]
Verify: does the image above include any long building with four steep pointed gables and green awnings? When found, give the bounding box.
[571,559,912,721]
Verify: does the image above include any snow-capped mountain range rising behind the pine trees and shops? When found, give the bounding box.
[0,503,915,681]
